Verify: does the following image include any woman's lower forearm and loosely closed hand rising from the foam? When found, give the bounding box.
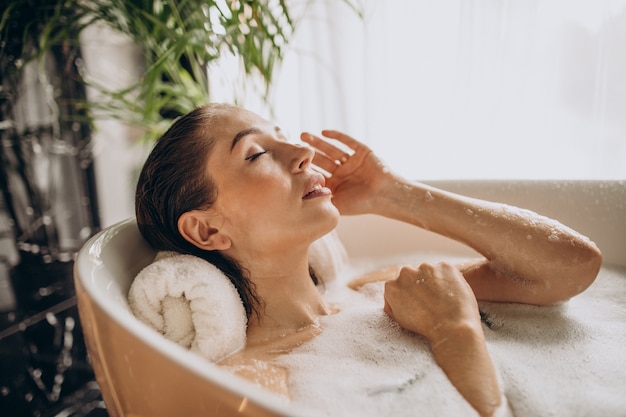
[385,263,508,416]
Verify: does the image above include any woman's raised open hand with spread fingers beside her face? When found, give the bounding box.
[301,130,391,215]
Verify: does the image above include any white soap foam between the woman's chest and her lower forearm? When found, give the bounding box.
[281,276,475,417]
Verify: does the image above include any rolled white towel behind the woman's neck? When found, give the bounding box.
[128,252,247,362]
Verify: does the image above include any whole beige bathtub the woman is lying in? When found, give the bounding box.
[75,181,626,417]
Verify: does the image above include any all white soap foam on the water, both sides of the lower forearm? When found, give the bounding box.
[278,256,626,417]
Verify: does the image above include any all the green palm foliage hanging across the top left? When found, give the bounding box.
[0,0,359,138]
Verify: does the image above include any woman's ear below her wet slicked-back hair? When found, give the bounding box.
[178,210,231,250]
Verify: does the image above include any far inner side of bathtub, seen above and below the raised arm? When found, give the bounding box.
[337,179,626,267]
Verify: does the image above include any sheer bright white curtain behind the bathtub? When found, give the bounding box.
[224,0,626,179]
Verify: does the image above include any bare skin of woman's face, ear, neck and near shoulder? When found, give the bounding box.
[178,105,339,395]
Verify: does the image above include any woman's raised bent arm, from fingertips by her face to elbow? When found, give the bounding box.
[302,131,602,304]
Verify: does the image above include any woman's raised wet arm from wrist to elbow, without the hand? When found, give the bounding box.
[373,179,602,304]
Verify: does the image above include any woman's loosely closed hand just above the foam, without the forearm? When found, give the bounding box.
[385,263,480,346]
